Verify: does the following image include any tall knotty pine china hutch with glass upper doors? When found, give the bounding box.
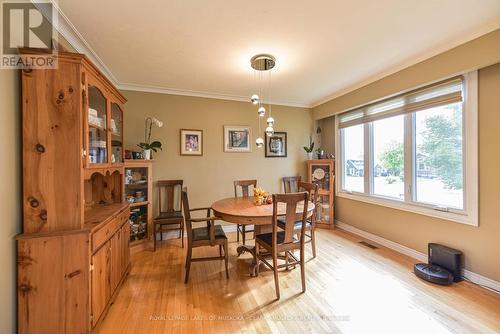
[16,50,130,333]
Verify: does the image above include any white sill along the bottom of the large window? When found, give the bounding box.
[337,191,478,227]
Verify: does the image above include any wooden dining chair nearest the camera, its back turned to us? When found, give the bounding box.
[255,191,309,299]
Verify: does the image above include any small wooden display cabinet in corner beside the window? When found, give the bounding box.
[307,159,335,228]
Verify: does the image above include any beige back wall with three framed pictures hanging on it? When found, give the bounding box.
[124,91,313,213]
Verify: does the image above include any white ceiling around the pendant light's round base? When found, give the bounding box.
[59,0,500,107]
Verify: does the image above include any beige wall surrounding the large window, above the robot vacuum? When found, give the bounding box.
[313,30,500,281]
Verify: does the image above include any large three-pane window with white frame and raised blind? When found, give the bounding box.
[337,72,477,225]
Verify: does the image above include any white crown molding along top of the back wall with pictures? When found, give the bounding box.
[117,83,311,108]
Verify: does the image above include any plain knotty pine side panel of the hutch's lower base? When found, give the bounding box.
[17,233,90,333]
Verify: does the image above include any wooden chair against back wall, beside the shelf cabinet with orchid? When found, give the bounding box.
[153,180,184,251]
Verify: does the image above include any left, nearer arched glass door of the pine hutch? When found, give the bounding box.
[87,85,108,164]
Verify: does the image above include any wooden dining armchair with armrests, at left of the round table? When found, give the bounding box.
[182,188,229,283]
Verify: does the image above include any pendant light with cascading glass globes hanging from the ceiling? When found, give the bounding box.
[250,54,276,148]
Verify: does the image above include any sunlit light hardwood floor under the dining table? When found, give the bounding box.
[100,229,500,334]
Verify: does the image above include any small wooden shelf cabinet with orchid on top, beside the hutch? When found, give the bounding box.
[125,160,153,249]
